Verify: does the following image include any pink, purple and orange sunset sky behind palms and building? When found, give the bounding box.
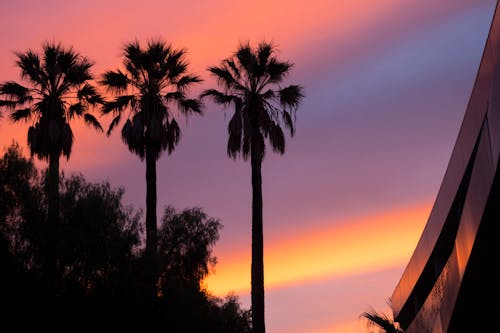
[0,0,496,333]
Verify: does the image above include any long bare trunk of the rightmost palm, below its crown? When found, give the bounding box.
[251,146,266,333]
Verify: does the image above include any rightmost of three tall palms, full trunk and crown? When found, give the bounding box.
[202,42,303,333]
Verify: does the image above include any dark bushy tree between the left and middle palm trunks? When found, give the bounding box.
[58,174,141,295]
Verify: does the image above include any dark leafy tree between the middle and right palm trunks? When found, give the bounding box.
[158,206,251,333]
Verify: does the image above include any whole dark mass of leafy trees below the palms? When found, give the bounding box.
[0,145,251,333]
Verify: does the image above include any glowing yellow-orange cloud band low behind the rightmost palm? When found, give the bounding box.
[205,203,431,295]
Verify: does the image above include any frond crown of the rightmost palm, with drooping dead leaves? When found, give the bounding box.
[202,42,303,159]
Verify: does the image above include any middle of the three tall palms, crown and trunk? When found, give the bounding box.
[101,41,201,293]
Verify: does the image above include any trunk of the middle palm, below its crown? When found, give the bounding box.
[146,148,158,297]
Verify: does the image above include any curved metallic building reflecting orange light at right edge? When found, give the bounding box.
[390,4,500,333]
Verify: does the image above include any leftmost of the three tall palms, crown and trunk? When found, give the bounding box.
[0,43,102,292]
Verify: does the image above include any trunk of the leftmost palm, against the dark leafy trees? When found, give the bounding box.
[45,152,59,302]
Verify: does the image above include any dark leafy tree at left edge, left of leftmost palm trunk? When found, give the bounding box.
[0,143,44,308]
